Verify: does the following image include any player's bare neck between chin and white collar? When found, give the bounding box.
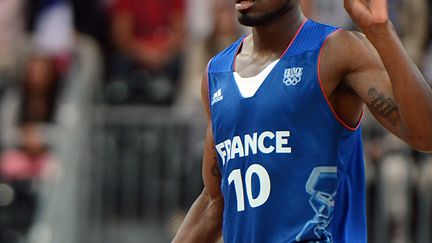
[252,8,305,54]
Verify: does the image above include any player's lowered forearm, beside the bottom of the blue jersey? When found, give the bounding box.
[173,190,223,243]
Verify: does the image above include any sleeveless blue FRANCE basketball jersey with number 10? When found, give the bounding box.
[208,20,366,243]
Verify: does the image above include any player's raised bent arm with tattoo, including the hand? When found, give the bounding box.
[337,0,432,151]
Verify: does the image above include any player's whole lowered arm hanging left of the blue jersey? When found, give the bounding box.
[173,69,224,243]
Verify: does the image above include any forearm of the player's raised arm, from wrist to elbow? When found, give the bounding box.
[363,22,432,151]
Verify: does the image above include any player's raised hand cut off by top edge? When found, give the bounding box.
[344,0,389,30]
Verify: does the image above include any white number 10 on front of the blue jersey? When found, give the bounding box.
[228,164,271,212]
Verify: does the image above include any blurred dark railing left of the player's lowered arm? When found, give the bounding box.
[88,106,205,243]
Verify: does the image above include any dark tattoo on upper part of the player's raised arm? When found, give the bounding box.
[368,88,400,126]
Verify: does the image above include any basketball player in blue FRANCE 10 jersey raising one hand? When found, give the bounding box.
[174,0,432,243]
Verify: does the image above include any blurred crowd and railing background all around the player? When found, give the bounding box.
[0,0,432,243]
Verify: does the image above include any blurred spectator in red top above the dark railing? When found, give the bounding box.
[107,0,185,104]
